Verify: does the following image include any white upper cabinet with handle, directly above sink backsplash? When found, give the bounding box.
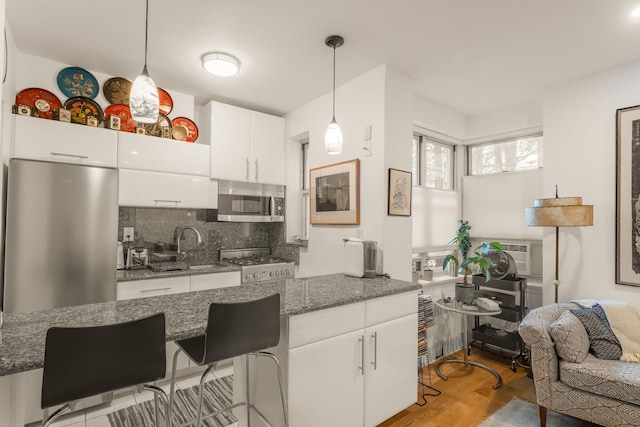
[118,169,212,209]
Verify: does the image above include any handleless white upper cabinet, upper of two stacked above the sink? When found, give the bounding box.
[118,132,211,176]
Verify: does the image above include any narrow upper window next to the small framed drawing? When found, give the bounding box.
[411,134,454,190]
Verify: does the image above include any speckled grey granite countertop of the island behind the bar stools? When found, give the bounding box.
[0,276,421,376]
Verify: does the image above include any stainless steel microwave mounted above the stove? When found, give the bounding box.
[218,179,285,222]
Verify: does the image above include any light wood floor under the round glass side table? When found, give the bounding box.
[378,348,536,427]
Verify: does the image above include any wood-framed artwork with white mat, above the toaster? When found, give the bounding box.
[309,159,360,225]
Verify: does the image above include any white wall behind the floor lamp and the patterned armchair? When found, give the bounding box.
[543,62,640,304]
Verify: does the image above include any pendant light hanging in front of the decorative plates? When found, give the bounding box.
[129,0,160,123]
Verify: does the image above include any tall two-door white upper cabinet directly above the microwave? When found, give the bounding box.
[201,101,284,185]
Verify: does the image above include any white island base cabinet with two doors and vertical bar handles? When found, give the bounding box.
[288,292,418,427]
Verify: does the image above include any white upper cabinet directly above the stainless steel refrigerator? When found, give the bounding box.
[12,115,120,167]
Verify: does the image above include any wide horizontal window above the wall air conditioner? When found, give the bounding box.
[468,135,542,175]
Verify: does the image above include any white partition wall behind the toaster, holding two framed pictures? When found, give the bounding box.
[286,66,412,280]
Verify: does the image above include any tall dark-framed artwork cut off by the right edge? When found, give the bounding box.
[616,106,640,286]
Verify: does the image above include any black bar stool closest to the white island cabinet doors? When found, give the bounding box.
[169,294,289,427]
